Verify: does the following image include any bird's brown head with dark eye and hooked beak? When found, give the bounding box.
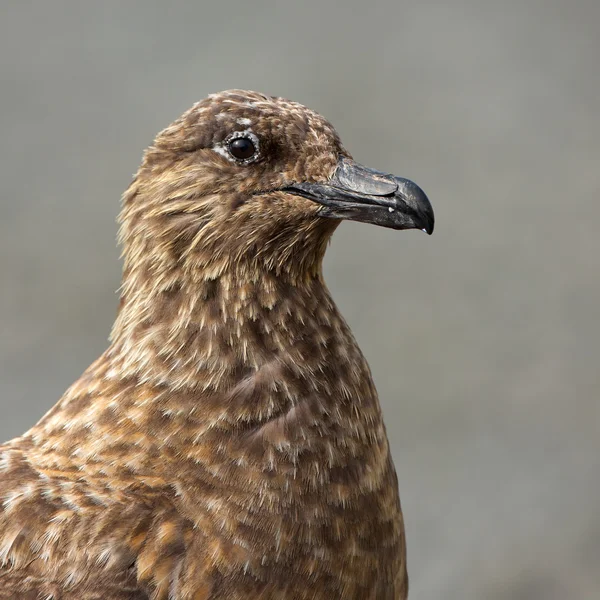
[121,90,434,278]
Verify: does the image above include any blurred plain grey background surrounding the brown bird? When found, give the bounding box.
[0,0,600,600]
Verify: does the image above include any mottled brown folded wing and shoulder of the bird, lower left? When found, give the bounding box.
[0,438,190,600]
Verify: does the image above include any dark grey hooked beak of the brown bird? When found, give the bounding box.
[283,157,434,235]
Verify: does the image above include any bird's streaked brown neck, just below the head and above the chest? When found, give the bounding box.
[108,269,342,384]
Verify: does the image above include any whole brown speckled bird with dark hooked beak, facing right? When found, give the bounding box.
[0,90,433,600]
